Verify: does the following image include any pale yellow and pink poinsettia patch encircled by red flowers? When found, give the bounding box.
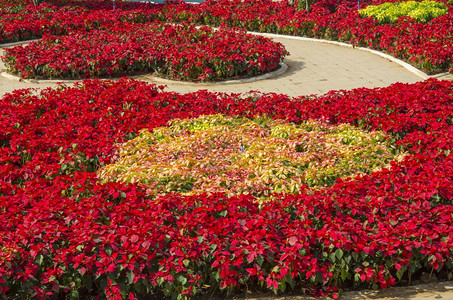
[100,115,402,196]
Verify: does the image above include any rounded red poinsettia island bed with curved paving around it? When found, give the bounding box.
[3,22,287,81]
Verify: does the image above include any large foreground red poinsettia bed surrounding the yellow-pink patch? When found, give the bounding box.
[0,79,453,299]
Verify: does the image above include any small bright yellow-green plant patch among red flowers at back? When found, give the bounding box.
[359,0,448,24]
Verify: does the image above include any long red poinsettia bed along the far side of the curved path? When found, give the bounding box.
[0,0,453,74]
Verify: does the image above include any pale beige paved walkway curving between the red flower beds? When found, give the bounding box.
[0,32,453,300]
